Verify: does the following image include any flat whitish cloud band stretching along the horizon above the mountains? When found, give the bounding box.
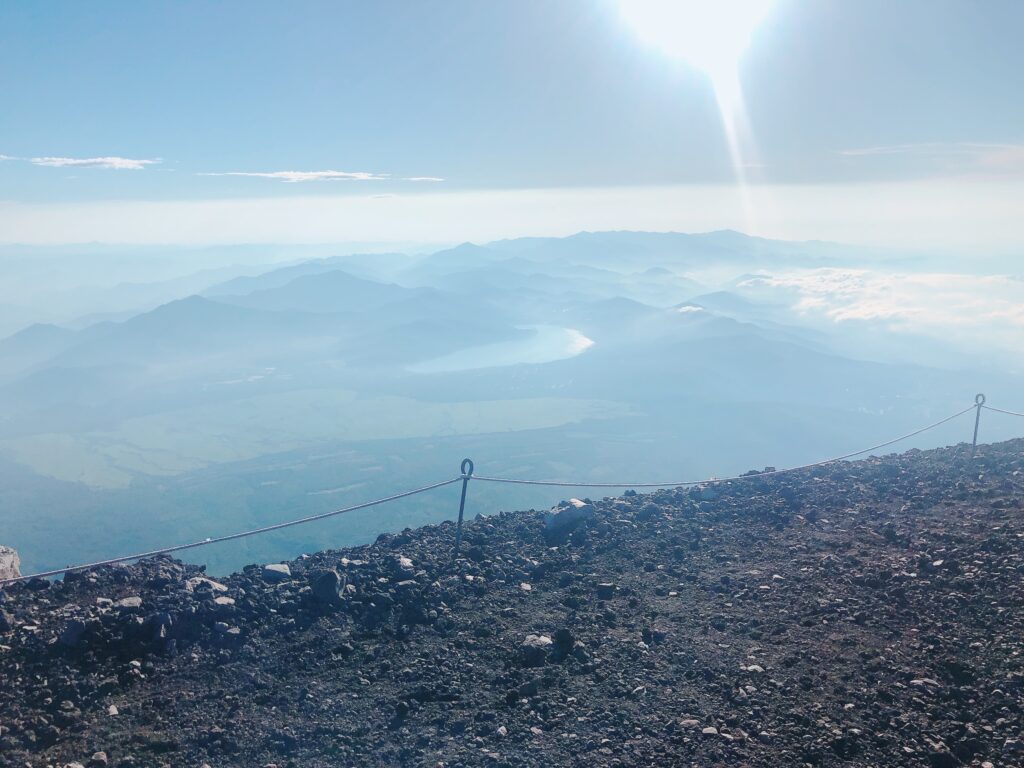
[0,181,1024,252]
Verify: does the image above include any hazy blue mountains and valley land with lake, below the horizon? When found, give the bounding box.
[0,232,1021,566]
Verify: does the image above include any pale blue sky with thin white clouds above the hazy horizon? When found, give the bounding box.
[0,0,1024,253]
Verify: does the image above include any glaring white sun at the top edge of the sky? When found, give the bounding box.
[620,0,772,88]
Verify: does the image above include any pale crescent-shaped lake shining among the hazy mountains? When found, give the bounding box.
[410,326,594,374]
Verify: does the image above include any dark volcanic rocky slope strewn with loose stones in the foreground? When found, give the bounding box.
[0,440,1024,768]
